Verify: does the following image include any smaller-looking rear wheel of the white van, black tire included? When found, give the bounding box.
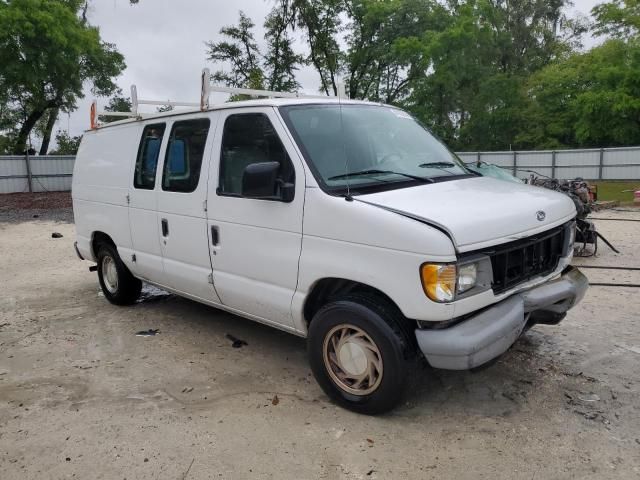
[97,244,142,305]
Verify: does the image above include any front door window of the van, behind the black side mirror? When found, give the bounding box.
[218,113,295,196]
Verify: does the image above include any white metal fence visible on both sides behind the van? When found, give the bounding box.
[0,147,640,193]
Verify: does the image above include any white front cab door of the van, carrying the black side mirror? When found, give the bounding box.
[207,107,305,328]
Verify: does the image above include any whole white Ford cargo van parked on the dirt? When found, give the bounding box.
[73,88,587,414]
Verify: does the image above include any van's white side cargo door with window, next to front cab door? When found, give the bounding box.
[157,113,220,303]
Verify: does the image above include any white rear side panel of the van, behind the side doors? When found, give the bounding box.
[72,126,138,267]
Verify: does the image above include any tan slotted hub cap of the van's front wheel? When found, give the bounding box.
[323,324,383,396]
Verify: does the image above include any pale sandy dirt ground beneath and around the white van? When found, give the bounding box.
[0,200,640,480]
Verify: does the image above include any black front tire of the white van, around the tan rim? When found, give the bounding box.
[307,294,417,415]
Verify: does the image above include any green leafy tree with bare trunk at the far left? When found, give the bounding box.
[0,0,125,153]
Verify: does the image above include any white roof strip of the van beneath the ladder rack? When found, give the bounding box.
[86,97,385,133]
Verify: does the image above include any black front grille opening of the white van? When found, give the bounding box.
[481,225,567,294]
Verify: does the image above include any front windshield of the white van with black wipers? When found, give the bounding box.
[281,104,470,193]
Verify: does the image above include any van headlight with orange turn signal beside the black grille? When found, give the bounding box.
[420,263,478,302]
